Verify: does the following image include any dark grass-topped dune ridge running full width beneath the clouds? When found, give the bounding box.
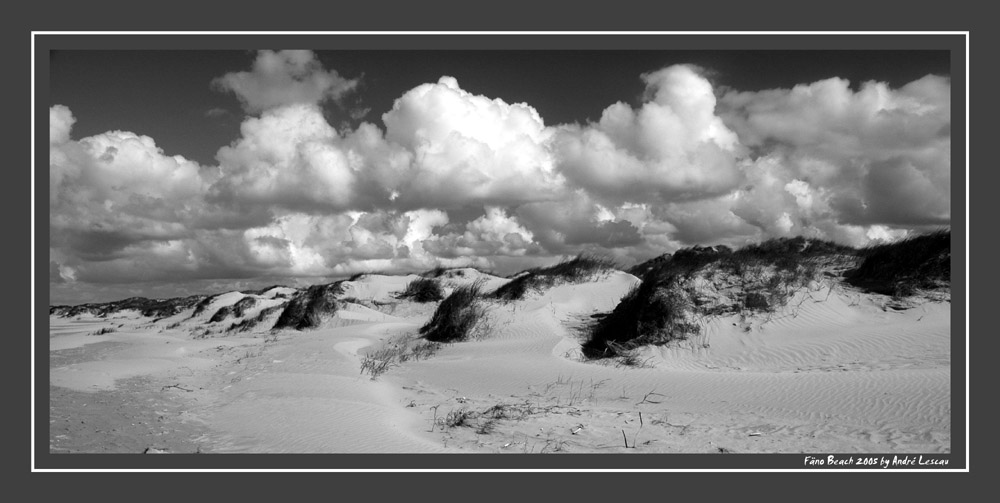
[49,230,951,358]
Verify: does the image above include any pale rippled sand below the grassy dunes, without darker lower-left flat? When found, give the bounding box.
[50,270,951,453]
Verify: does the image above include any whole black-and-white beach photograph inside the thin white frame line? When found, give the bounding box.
[34,35,967,469]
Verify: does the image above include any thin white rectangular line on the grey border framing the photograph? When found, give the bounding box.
[29,30,971,473]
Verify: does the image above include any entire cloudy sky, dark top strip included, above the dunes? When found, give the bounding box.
[48,50,951,304]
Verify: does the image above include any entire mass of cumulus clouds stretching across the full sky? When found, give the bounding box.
[49,56,950,298]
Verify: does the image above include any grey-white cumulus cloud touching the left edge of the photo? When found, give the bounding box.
[49,105,238,282]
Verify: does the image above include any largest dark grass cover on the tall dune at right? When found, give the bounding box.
[582,231,951,359]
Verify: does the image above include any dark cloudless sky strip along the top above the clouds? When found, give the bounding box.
[49,50,950,164]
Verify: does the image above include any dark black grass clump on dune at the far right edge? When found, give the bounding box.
[845,230,951,297]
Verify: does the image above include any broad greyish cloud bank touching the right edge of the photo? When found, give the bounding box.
[720,75,951,226]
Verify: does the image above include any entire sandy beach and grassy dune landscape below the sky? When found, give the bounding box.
[49,231,951,453]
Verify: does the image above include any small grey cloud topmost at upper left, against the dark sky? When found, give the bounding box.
[212,50,358,113]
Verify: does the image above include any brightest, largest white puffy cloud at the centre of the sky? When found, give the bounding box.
[382,77,562,207]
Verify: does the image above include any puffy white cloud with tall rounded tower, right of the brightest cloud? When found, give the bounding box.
[556,65,740,202]
